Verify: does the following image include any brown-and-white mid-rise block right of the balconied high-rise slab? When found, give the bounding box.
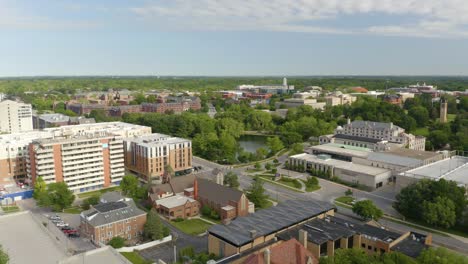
[124,133,192,182]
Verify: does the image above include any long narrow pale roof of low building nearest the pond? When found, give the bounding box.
[291,153,389,175]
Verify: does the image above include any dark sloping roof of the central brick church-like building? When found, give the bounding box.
[197,179,244,206]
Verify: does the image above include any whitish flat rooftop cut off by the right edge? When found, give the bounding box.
[401,156,468,185]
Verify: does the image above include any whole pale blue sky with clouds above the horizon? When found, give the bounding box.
[0,0,468,76]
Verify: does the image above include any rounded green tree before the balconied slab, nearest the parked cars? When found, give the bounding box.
[46,182,75,211]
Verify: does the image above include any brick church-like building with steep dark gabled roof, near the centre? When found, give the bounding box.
[193,178,254,221]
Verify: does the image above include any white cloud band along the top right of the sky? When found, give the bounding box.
[131,0,468,37]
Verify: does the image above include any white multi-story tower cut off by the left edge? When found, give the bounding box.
[0,100,33,133]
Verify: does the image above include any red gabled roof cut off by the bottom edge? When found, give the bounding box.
[244,239,318,264]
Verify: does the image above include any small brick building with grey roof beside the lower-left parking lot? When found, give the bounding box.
[80,194,146,245]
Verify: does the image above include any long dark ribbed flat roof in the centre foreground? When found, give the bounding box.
[208,200,335,247]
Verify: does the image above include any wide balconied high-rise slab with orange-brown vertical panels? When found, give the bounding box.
[27,133,125,192]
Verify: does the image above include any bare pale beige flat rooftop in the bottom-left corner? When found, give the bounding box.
[0,212,67,264]
